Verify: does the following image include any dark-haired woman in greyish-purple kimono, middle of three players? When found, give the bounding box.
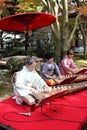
[41,53,61,85]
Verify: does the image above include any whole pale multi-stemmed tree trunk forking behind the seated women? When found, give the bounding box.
[42,0,82,61]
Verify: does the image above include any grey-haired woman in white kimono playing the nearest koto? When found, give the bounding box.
[13,58,51,105]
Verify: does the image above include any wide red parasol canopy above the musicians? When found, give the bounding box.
[0,12,56,31]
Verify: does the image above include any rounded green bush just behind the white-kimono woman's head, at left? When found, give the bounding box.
[6,57,23,72]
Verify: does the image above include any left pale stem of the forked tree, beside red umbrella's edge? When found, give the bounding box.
[42,0,61,62]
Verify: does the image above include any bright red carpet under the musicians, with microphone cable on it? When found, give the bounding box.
[0,90,87,130]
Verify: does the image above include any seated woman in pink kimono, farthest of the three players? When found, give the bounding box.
[60,49,79,75]
